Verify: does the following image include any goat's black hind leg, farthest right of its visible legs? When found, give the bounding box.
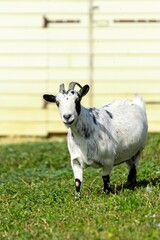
[126,152,140,190]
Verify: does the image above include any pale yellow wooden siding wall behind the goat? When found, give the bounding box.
[0,0,160,135]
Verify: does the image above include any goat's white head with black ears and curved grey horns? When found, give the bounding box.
[43,82,89,126]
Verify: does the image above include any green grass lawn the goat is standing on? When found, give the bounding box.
[0,134,160,240]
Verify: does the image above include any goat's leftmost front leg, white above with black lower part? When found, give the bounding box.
[72,159,83,199]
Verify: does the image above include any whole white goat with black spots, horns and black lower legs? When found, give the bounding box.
[43,82,148,195]
